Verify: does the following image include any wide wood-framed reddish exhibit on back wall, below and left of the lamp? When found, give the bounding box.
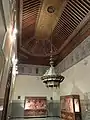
[24,97,47,117]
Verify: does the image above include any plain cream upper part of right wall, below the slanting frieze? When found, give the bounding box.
[58,56,90,99]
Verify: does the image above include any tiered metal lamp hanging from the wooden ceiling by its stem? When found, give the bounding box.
[41,38,64,88]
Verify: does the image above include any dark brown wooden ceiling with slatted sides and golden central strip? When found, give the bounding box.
[16,0,90,65]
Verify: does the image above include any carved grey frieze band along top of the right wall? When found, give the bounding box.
[56,36,90,73]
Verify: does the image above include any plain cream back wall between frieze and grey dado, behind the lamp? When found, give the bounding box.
[12,75,52,100]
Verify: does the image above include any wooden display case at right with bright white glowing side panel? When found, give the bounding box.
[60,95,82,120]
